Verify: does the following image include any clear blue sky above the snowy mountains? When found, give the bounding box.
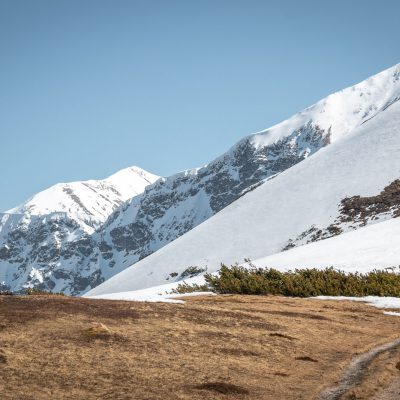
[0,0,400,211]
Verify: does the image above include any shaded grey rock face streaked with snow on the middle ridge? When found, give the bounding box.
[102,122,330,263]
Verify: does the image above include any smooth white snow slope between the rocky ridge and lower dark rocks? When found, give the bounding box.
[88,96,400,295]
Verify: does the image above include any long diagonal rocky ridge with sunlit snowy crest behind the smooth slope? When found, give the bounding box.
[89,65,400,286]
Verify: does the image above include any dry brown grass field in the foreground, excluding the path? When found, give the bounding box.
[0,296,400,400]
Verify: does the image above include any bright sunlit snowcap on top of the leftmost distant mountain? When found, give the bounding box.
[6,167,159,227]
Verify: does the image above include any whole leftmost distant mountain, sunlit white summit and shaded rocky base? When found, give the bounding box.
[0,167,159,292]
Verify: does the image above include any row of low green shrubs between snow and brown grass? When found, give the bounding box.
[176,265,400,297]
